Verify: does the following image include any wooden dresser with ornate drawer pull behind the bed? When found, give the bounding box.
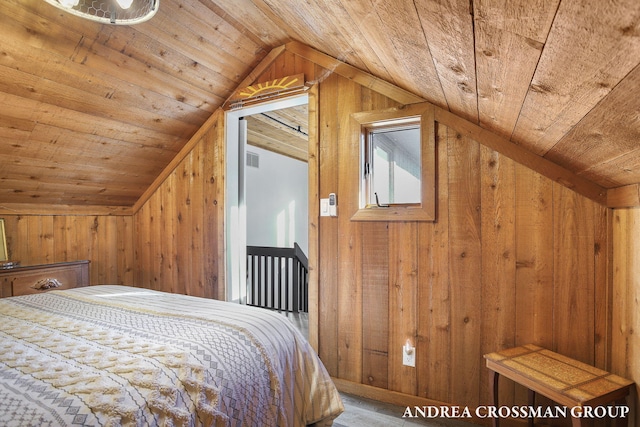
[0,261,89,298]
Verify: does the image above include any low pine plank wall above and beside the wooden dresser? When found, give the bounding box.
[2,214,134,285]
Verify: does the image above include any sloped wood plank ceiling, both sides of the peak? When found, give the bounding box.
[0,0,640,207]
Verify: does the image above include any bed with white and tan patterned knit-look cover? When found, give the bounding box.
[0,285,343,426]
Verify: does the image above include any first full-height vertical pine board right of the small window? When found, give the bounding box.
[448,126,483,405]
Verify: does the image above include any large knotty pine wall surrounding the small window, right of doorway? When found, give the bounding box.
[268,55,611,412]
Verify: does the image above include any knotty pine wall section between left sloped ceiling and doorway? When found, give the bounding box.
[133,114,225,299]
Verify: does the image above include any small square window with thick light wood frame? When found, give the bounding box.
[351,104,436,221]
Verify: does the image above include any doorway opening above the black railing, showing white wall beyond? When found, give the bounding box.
[244,104,309,254]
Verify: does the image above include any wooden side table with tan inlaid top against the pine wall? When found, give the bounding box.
[484,344,634,427]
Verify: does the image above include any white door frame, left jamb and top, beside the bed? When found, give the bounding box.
[225,93,309,304]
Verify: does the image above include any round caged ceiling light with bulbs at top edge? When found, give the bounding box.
[44,0,160,25]
